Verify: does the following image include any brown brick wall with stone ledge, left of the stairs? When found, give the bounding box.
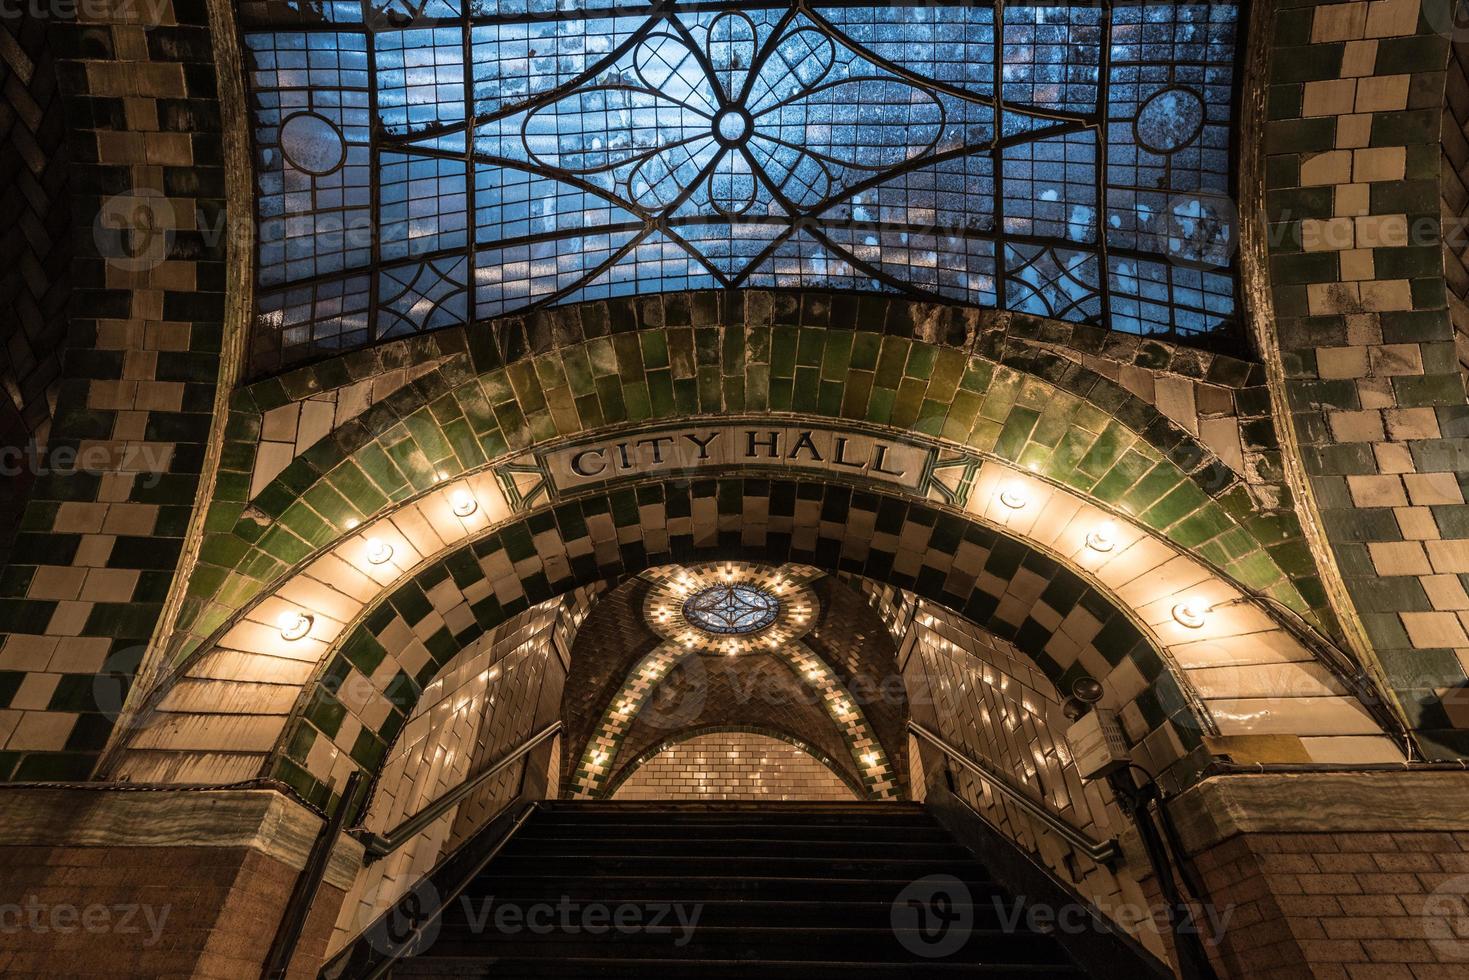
[0,788,361,980]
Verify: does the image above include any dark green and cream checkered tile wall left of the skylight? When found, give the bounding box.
[0,0,238,780]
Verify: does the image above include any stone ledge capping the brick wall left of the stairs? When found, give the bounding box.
[0,788,363,890]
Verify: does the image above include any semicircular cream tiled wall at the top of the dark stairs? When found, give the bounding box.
[613,732,856,802]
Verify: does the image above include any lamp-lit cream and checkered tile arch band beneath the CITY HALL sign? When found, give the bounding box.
[106,463,1396,801]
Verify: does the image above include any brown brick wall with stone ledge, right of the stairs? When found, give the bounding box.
[1169,770,1469,980]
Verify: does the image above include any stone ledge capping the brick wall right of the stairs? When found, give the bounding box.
[1168,770,1469,854]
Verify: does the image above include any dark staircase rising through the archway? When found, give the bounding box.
[389,802,1086,980]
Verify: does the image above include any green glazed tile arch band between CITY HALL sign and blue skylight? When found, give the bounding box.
[157,292,1332,693]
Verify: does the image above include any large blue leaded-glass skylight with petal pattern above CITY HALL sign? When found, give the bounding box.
[242,0,1238,369]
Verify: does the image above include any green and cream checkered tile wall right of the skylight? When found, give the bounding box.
[1246,0,1469,758]
